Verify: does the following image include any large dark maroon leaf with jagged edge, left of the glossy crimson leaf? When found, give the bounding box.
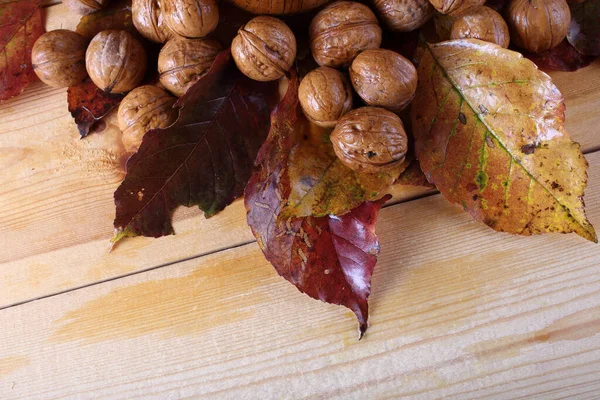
[112,50,277,243]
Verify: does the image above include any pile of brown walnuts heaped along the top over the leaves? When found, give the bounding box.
[32,0,571,169]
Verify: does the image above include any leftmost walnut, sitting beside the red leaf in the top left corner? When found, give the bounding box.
[31,29,87,87]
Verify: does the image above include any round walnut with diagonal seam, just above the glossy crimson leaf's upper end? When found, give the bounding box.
[231,16,296,81]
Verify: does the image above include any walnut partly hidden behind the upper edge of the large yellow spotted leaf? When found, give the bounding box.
[450,7,510,49]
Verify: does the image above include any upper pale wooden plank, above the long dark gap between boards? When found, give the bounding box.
[0,4,600,307]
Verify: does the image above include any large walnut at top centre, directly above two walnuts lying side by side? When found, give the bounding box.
[309,1,381,68]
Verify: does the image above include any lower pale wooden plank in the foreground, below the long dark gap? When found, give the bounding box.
[0,152,600,400]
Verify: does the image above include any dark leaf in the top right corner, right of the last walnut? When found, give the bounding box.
[567,0,600,56]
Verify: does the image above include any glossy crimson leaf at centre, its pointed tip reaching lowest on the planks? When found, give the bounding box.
[244,71,387,337]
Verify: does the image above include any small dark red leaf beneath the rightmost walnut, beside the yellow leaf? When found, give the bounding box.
[517,39,596,71]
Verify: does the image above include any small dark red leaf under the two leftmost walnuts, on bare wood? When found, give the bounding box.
[67,77,125,137]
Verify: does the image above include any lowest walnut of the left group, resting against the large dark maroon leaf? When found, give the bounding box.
[117,85,177,152]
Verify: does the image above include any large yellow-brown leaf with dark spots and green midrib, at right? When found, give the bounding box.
[412,39,597,242]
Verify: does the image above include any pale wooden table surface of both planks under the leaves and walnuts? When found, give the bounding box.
[0,4,600,399]
